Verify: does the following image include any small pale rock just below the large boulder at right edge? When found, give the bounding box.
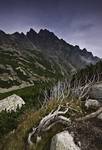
[85,99,101,109]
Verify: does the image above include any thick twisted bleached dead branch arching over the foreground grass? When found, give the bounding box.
[28,105,71,145]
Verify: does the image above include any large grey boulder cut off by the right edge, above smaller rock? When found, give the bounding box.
[89,82,102,100]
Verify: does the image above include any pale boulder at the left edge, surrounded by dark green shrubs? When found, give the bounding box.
[0,94,25,112]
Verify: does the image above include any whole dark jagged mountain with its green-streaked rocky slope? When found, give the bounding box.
[0,29,99,92]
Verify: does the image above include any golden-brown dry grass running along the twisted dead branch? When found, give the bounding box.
[0,99,82,150]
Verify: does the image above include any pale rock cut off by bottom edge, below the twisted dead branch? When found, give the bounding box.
[50,131,80,150]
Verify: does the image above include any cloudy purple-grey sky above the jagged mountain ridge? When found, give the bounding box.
[0,0,102,58]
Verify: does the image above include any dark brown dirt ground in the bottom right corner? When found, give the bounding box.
[68,119,102,150]
